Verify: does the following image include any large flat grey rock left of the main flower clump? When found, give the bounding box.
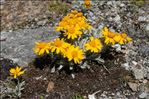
[0,27,58,66]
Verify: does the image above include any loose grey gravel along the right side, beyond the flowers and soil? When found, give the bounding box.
[75,1,149,99]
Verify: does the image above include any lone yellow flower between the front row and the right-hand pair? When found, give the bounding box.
[85,37,103,53]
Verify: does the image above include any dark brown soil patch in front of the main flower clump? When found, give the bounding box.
[22,47,131,99]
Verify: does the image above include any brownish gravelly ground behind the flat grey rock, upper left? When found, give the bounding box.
[0,0,70,31]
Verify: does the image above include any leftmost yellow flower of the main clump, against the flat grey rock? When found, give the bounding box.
[33,42,51,55]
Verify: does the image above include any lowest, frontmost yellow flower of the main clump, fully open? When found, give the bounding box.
[65,46,85,64]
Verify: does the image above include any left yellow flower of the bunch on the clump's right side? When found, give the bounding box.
[102,27,117,45]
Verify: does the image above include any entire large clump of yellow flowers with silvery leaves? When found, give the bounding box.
[34,9,132,70]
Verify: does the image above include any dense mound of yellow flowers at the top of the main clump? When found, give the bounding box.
[56,10,91,39]
